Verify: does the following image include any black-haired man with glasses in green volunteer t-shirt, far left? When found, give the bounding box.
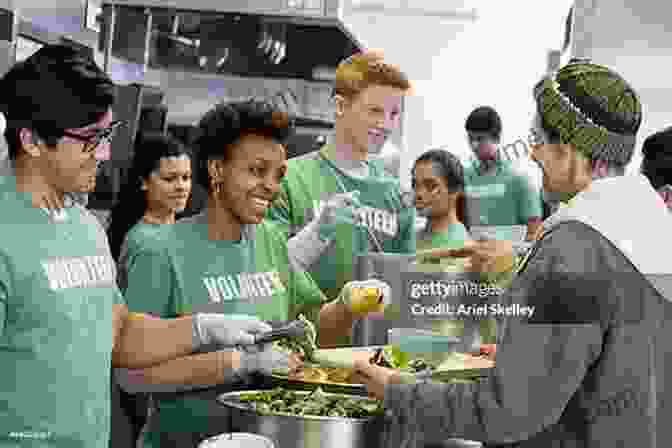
[0,45,280,448]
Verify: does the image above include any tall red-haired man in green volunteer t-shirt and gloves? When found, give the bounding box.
[269,52,415,346]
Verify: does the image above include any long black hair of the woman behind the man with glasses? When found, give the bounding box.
[107,133,190,261]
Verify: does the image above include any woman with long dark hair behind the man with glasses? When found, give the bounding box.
[107,134,191,448]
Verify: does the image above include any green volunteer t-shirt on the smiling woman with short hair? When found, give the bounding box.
[125,212,324,445]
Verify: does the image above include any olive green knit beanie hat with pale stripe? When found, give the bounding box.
[534,60,642,166]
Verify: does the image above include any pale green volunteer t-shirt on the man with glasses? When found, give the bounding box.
[0,179,123,448]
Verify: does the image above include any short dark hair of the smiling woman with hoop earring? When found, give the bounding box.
[194,99,294,191]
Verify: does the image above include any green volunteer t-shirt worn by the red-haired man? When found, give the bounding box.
[268,145,416,300]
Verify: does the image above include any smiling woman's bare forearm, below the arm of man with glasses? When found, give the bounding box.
[115,350,241,393]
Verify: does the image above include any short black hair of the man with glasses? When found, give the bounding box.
[0,44,116,159]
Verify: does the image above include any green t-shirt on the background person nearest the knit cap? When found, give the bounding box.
[464,161,542,231]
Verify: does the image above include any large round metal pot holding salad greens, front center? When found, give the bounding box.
[217,391,385,448]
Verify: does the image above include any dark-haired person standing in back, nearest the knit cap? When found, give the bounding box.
[464,106,543,241]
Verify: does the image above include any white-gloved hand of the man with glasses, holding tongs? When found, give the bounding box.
[193,314,273,350]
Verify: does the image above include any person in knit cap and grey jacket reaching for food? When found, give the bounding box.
[356,61,672,448]
